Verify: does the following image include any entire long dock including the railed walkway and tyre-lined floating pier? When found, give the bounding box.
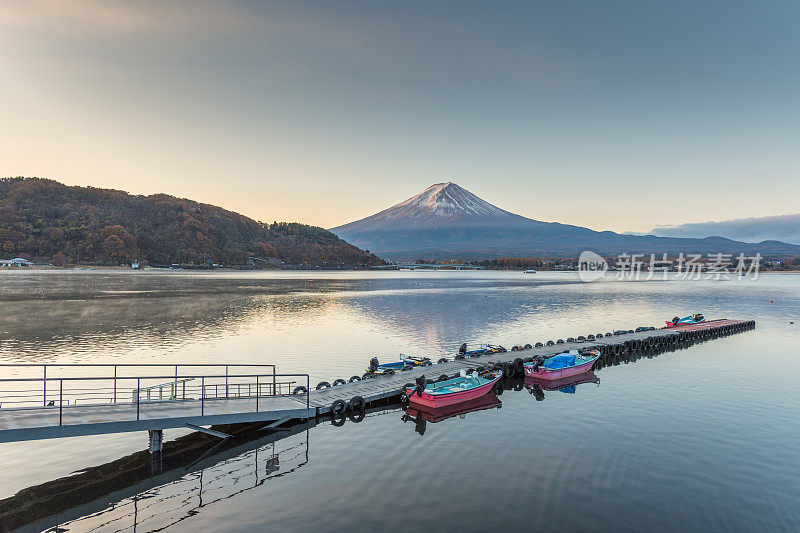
[0,319,755,444]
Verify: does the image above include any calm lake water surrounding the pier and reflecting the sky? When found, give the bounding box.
[0,271,800,532]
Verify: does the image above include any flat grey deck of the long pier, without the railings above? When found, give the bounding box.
[0,319,755,442]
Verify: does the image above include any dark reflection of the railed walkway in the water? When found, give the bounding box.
[5,421,314,531]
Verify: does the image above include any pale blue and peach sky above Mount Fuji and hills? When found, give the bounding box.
[0,0,800,231]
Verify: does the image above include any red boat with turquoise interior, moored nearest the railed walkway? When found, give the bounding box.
[405,370,503,409]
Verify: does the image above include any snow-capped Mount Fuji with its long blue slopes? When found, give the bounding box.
[331,182,800,260]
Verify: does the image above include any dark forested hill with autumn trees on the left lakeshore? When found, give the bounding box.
[0,178,381,267]
